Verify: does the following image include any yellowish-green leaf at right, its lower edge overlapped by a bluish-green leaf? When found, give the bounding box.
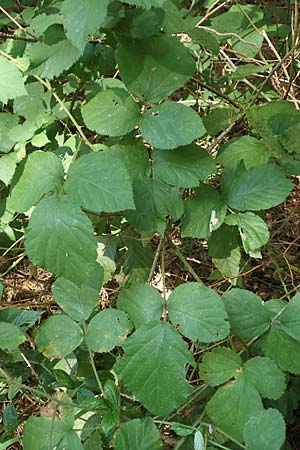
[217,134,271,170]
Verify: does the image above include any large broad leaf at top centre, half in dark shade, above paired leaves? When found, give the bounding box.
[115,35,195,102]
